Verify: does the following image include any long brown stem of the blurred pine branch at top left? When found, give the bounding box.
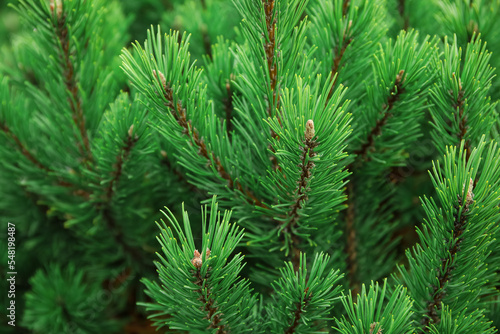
[50,1,92,161]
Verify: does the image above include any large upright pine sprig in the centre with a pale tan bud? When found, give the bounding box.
[247,77,350,266]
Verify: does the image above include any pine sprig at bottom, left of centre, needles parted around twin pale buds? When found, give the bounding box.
[143,197,259,333]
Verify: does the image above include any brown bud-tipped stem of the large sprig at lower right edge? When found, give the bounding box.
[421,187,474,333]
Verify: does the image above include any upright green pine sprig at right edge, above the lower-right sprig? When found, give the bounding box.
[430,36,497,158]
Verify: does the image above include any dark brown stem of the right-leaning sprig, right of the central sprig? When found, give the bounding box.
[354,70,405,161]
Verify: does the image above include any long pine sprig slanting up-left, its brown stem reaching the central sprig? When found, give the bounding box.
[122,29,266,207]
